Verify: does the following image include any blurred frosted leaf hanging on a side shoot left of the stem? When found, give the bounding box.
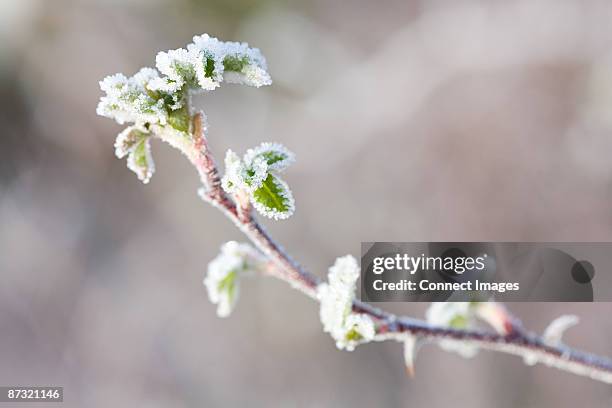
[204,241,265,317]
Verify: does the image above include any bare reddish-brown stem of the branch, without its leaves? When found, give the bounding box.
[158,113,612,384]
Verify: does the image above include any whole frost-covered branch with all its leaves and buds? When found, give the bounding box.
[98,35,612,383]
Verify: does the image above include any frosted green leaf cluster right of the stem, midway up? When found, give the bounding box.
[221,143,295,220]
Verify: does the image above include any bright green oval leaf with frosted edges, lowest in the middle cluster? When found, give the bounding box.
[252,174,295,220]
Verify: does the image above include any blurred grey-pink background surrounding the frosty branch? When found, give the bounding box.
[0,0,612,408]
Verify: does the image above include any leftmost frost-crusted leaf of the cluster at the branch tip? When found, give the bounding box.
[96,68,167,125]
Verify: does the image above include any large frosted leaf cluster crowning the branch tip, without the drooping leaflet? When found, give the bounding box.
[97,34,272,131]
